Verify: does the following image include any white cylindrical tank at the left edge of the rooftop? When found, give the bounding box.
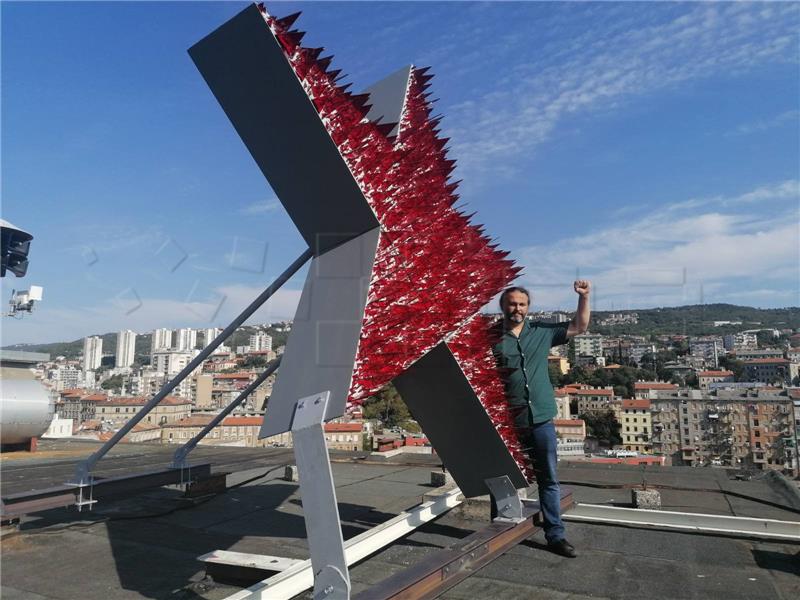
[0,377,53,445]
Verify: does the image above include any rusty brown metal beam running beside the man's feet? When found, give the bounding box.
[354,491,573,600]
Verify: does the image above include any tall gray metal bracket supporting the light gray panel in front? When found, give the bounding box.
[292,392,350,600]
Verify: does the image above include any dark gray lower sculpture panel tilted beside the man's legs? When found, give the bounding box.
[394,343,528,497]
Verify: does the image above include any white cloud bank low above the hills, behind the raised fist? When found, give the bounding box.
[515,181,800,309]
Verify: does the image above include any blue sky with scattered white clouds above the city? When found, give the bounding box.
[2,2,800,345]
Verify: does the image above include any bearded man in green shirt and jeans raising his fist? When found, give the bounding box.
[493,279,591,558]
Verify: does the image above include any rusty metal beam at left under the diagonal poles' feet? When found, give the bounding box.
[0,463,211,520]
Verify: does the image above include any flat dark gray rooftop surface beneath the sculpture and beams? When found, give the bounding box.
[0,441,800,600]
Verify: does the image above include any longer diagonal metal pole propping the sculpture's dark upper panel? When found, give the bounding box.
[70,248,314,486]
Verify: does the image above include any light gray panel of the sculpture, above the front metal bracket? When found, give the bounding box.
[260,228,380,438]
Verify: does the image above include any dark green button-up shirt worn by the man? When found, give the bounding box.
[492,320,569,427]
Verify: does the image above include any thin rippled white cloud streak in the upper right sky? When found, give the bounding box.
[443,3,800,180]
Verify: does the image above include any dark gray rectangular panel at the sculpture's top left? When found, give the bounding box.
[189,4,378,255]
